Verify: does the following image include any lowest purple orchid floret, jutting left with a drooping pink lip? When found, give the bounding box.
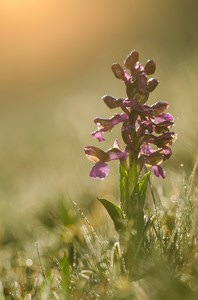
[84,141,128,179]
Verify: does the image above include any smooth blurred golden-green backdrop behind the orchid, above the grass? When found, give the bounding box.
[0,0,198,244]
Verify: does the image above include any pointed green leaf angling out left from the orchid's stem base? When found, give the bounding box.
[98,198,124,232]
